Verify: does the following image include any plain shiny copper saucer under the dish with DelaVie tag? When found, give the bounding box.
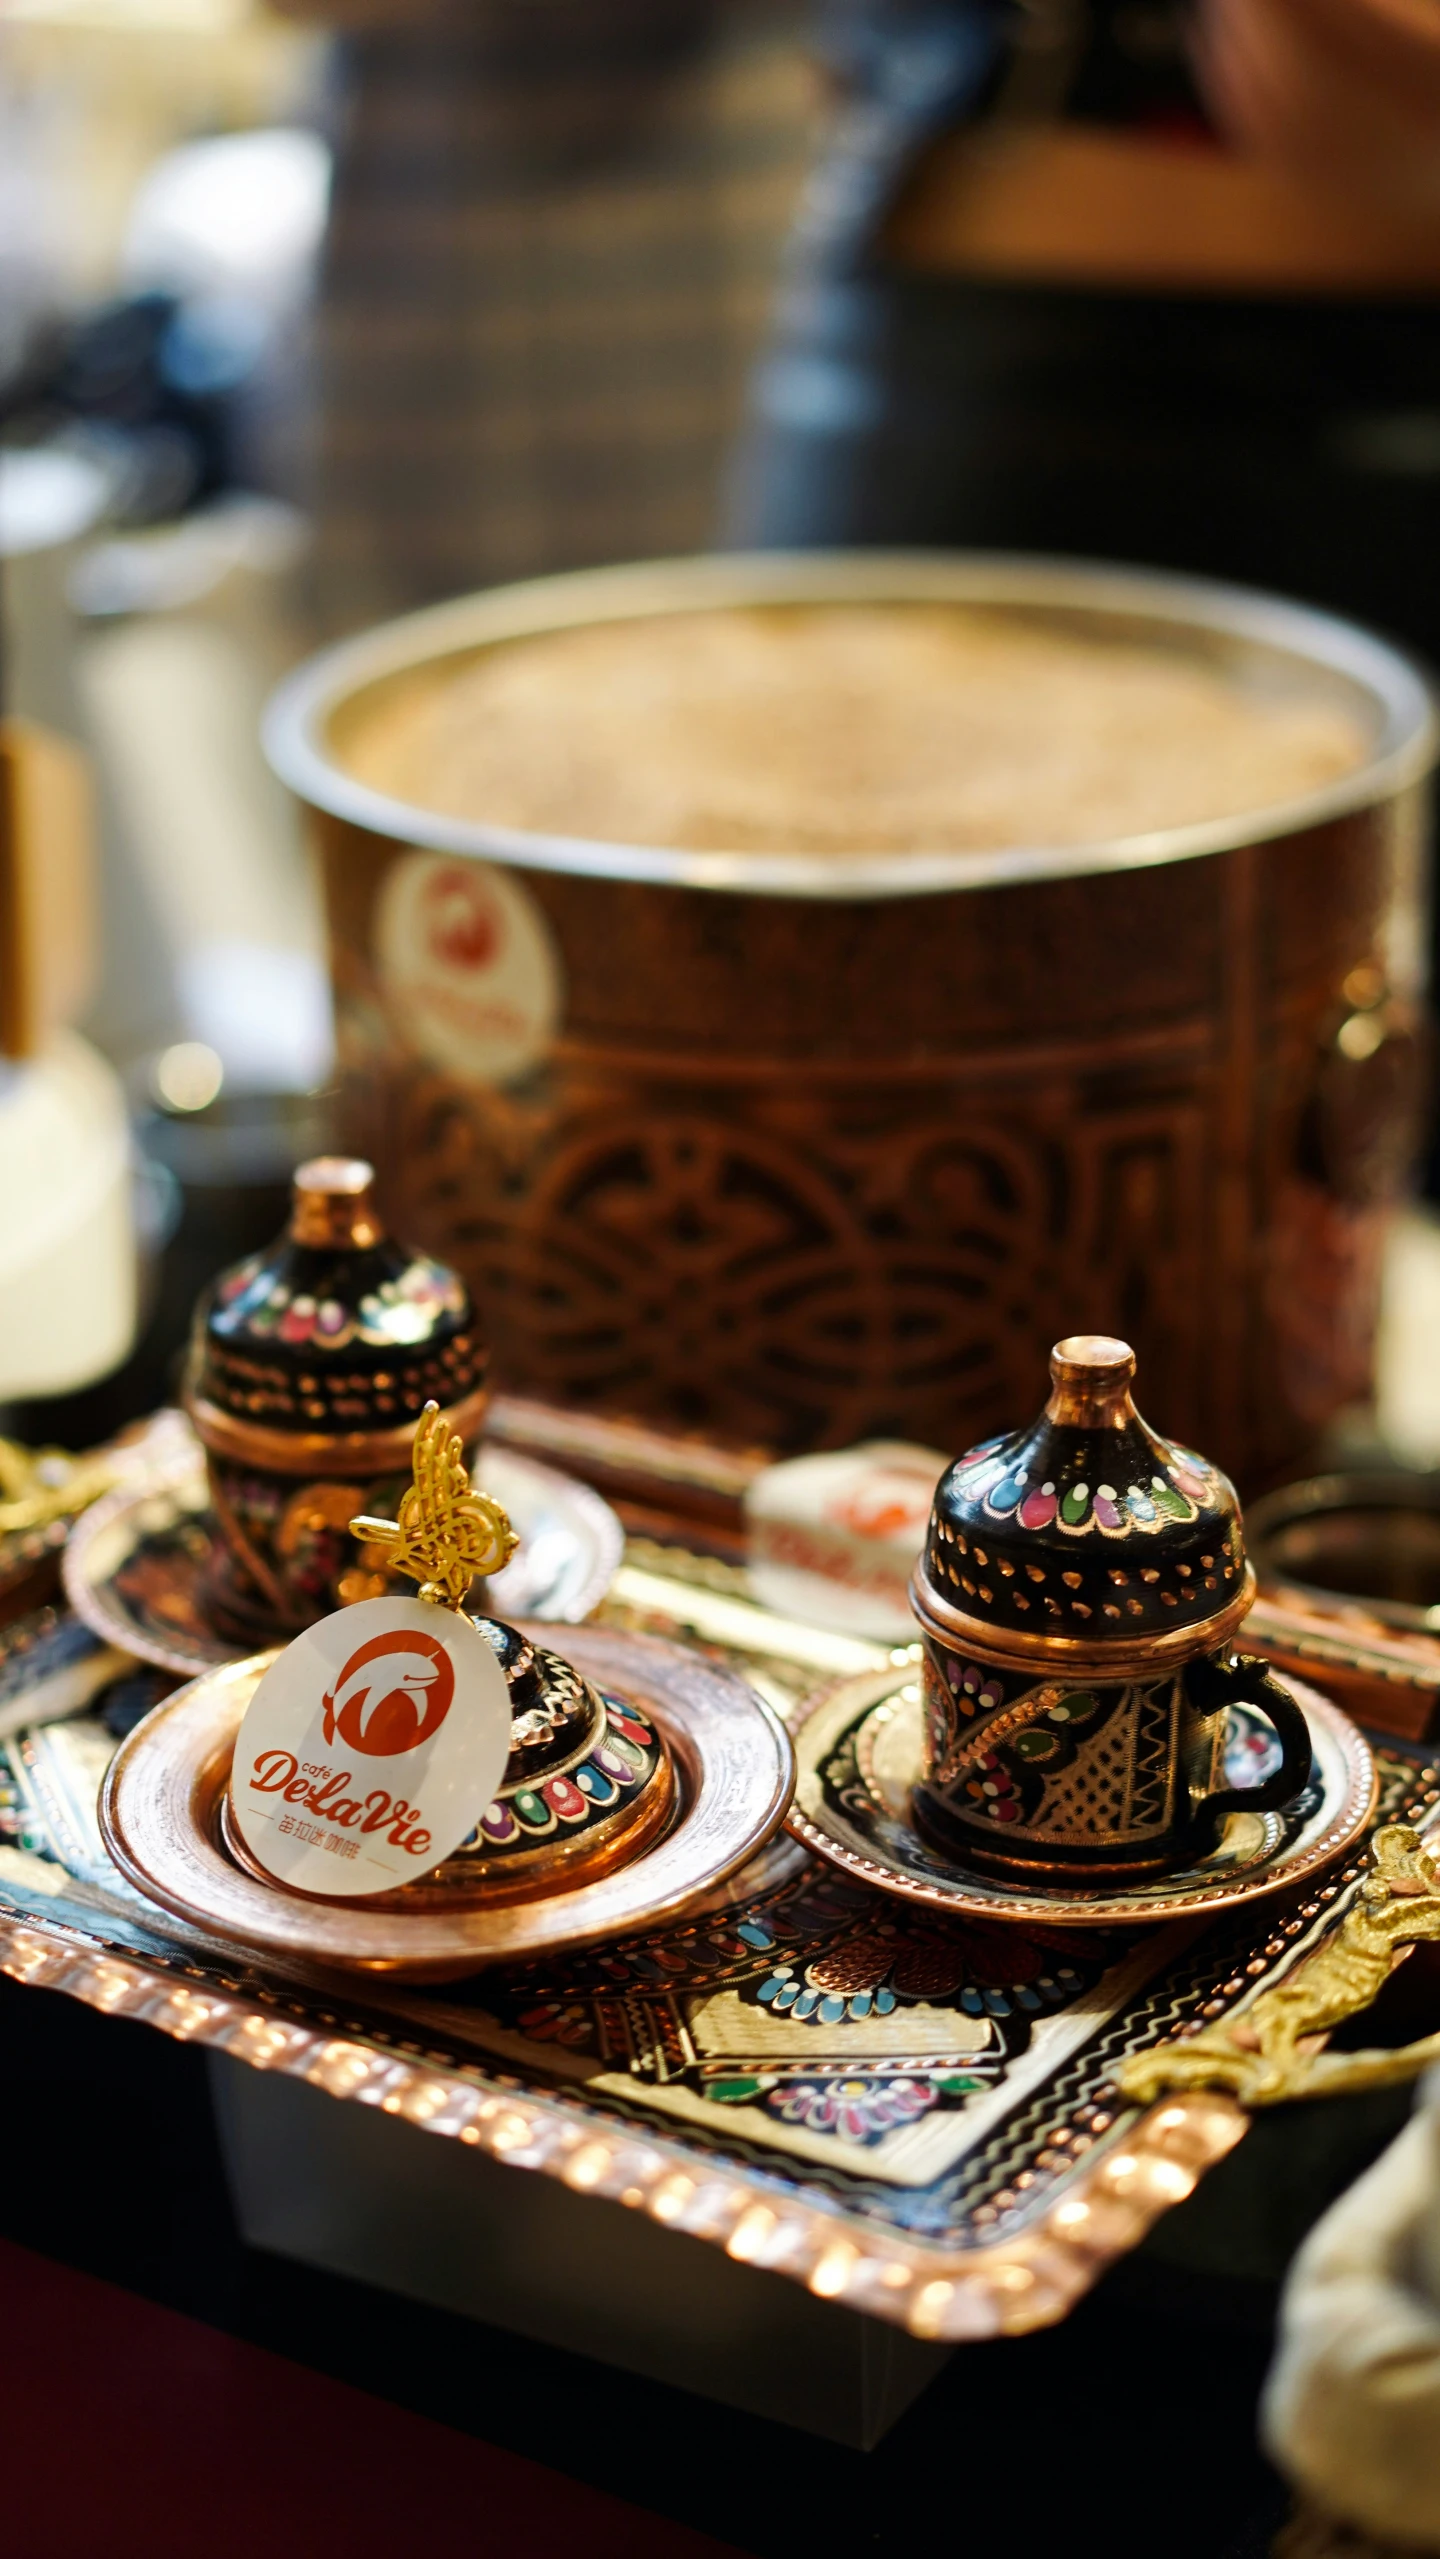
[100,1628,795,1981]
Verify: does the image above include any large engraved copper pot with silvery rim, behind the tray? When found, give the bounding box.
[269,553,1435,1484]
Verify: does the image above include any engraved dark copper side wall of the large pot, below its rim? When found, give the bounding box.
[320,711,1407,1484]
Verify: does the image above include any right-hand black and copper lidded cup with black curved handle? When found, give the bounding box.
[911,1333,1310,1883]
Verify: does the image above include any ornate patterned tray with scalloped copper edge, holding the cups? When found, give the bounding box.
[0,1576,1440,2339]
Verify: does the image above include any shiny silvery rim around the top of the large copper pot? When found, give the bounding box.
[263,550,1440,903]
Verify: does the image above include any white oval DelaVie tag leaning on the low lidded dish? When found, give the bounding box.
[230,1599,509,1901]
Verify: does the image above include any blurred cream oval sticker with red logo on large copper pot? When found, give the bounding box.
[373,852,563,1085]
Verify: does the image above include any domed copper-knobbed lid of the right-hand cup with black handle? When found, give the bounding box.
[913,1333,1256,1674]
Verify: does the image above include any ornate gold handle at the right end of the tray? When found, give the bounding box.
[1115,1822,1440,2106]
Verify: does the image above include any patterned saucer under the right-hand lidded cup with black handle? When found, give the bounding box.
[785,1668,1376,1927]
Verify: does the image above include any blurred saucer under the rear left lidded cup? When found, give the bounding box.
[64,1413,624,1679]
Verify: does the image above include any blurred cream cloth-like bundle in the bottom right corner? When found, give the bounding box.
[1261,2073,1440,2551]
